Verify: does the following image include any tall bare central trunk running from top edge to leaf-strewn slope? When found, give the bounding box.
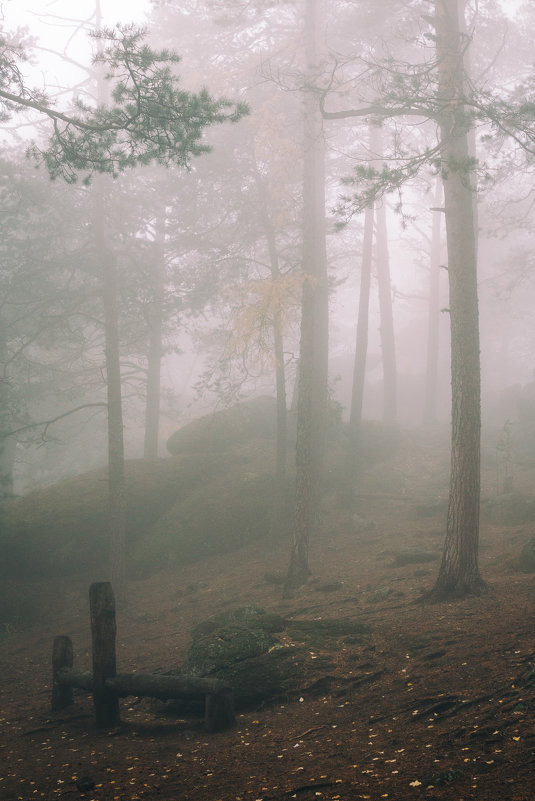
[285,0,328,592]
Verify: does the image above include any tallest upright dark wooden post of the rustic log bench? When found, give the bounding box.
[89,581,121,729]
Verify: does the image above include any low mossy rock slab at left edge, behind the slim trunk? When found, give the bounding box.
[0,457,221,578]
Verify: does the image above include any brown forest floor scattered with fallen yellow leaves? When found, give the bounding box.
[0,424,535,801]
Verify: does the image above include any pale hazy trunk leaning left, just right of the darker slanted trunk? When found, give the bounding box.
[374,126,398,424]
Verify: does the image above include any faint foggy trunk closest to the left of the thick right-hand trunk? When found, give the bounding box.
[423,177,442,426]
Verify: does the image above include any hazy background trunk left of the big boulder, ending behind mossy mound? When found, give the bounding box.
[143,209,165,459]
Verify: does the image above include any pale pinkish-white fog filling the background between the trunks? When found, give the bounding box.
[0,0,533,494]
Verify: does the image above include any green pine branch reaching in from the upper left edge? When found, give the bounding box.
[0,26,247,183]
